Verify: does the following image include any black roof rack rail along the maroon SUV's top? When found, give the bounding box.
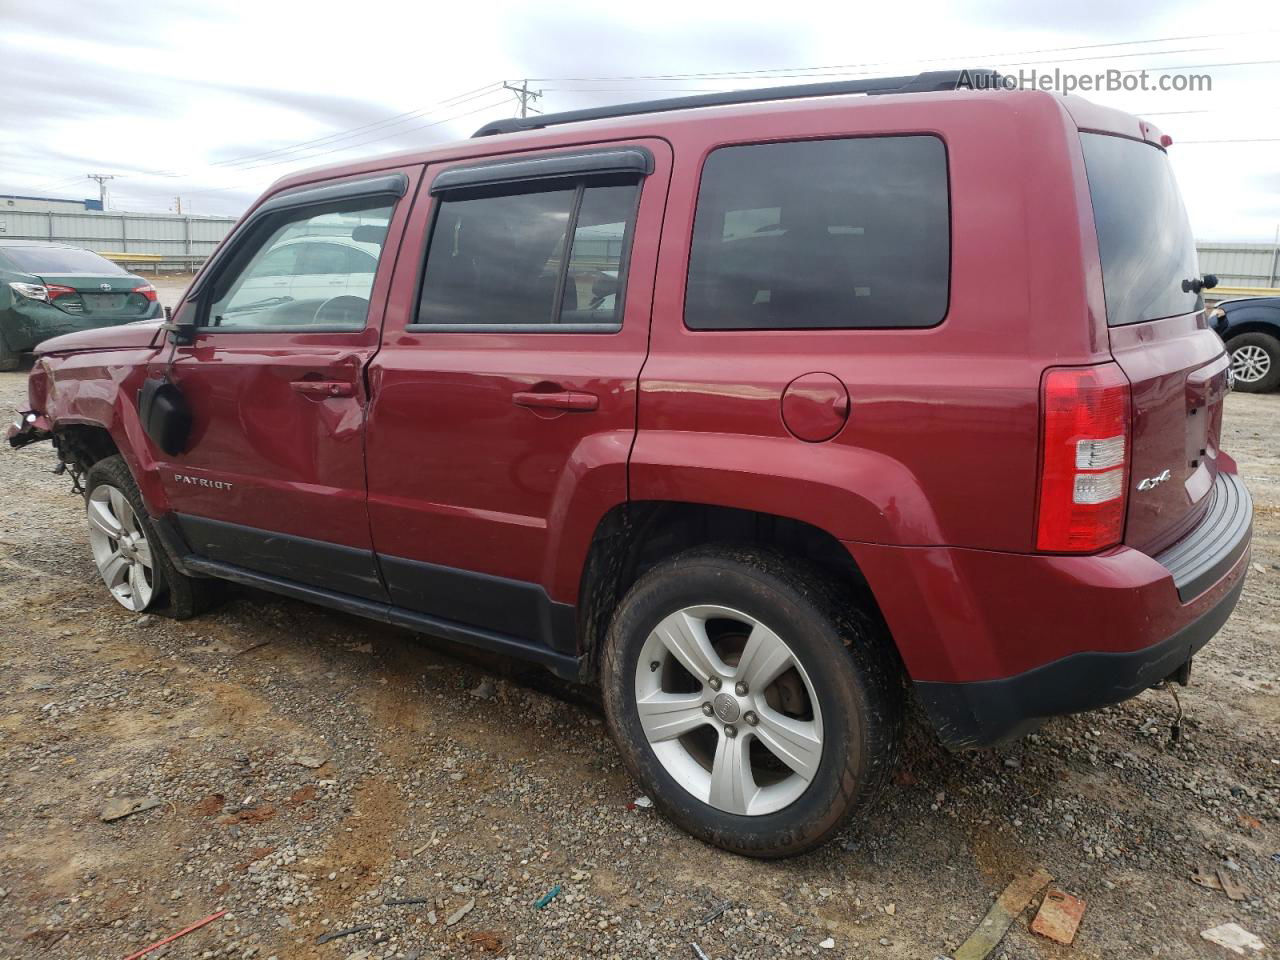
[471,68,1000,137]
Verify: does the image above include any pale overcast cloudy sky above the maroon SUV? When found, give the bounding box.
[0,0,1280,241]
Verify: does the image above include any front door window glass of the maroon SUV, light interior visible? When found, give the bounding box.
[204,198,393,330]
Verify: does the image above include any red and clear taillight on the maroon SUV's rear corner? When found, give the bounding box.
[1036,364,1129,553]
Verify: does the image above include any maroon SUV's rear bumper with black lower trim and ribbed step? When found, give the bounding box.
[847,472,1253,749]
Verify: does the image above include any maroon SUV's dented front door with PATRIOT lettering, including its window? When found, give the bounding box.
[152,168,421,600]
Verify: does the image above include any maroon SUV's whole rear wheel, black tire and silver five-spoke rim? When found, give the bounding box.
[600,548,901,856]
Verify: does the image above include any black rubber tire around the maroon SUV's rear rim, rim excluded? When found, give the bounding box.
[600,547,904,858]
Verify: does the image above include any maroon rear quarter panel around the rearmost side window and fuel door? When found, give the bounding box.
[631,93,1108,555]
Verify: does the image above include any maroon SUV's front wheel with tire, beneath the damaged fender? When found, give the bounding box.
[84,456,219,620]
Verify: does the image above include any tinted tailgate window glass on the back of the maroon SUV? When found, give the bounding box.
[1080,133,1204,326]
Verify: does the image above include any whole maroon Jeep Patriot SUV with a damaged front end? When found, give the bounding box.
[10,73,1252,856]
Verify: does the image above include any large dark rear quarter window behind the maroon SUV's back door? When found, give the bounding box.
[685,136,951,330]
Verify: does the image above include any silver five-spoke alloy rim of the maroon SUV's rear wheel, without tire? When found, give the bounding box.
[635,605,823,817]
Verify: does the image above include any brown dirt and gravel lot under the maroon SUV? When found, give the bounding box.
[0,374,1280,960]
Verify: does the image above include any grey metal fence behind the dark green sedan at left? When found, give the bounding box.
[0,210,236,269]
